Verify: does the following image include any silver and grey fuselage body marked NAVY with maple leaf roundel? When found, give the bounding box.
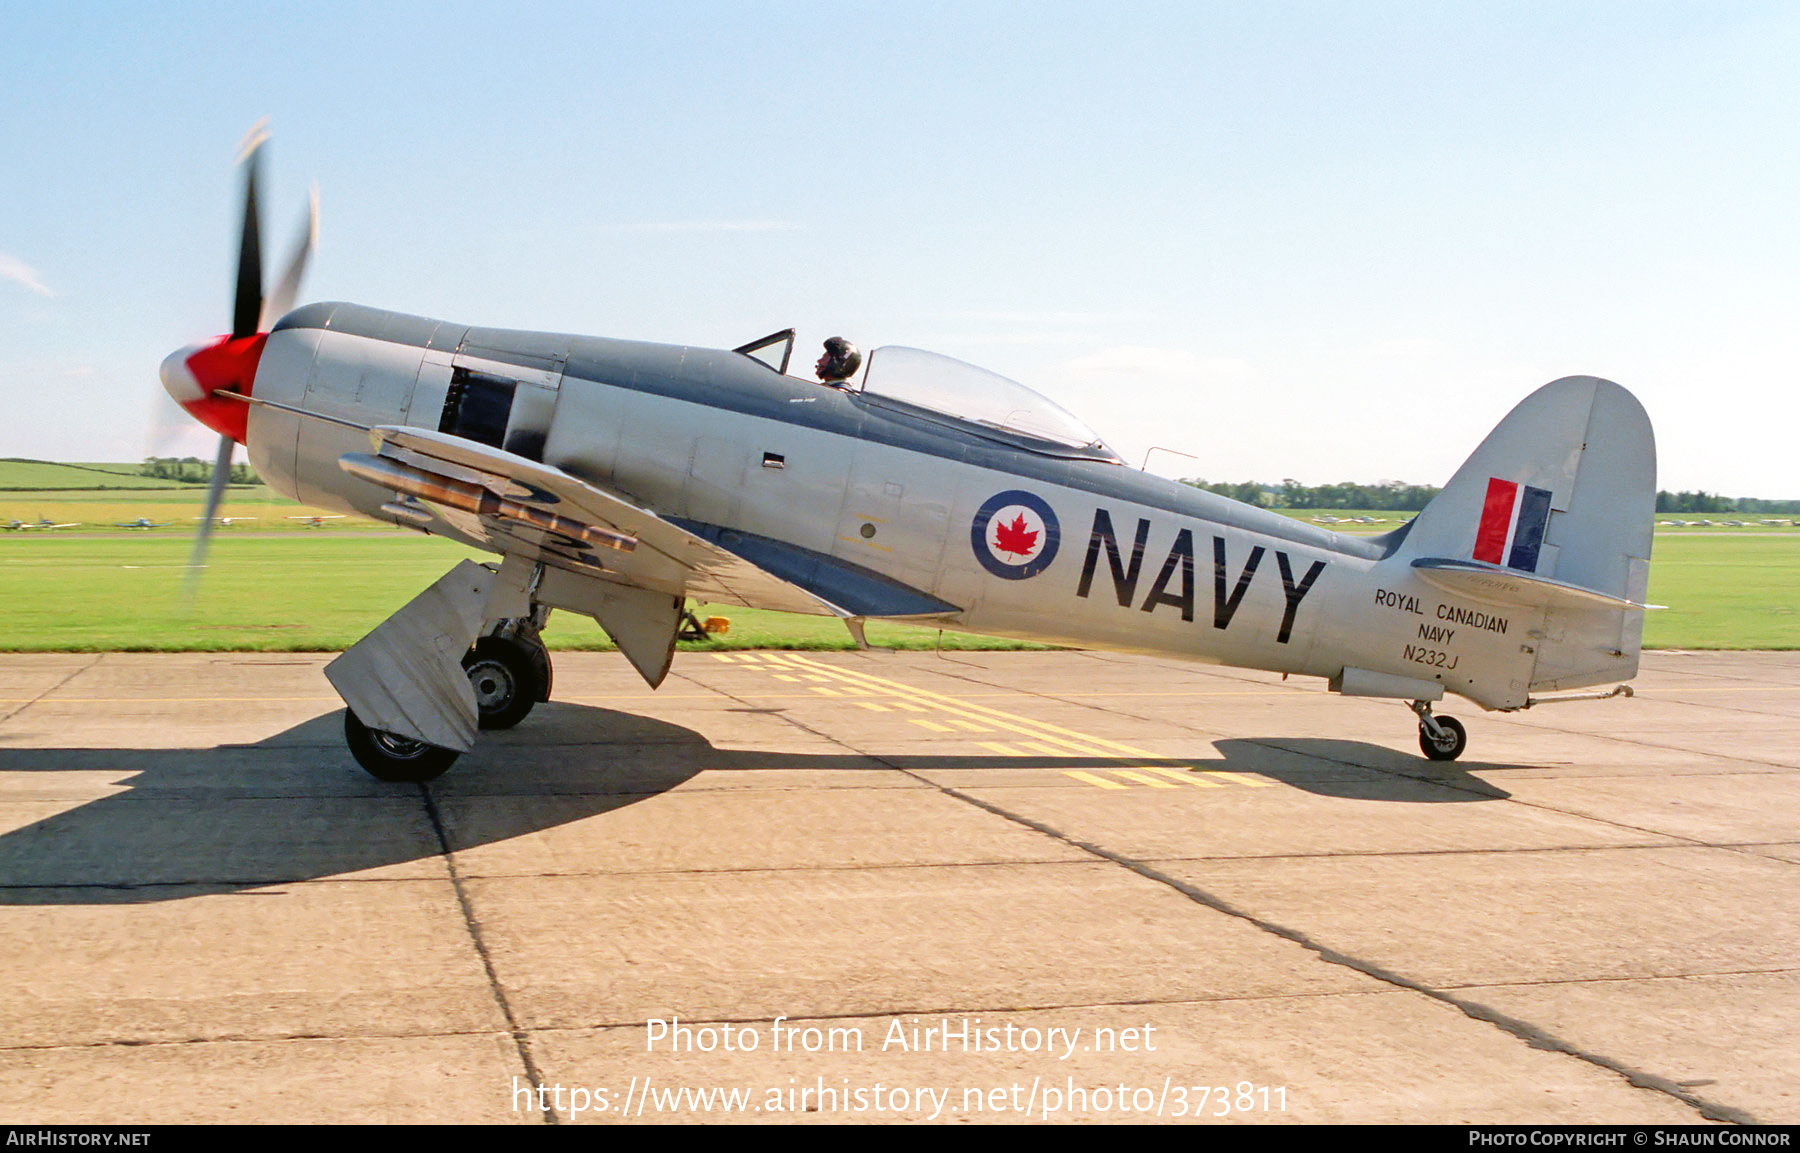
[247,304,1534,707]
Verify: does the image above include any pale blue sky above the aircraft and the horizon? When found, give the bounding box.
[0,0,1800,498]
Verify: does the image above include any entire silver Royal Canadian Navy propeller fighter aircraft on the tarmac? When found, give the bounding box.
[162,136,1656,781]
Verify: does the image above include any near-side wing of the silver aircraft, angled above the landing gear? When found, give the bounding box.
[340,426,958,617]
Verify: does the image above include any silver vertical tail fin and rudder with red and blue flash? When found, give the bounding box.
[1395,376,1656,689]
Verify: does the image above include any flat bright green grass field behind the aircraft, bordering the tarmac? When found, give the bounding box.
[0,520,1800,651]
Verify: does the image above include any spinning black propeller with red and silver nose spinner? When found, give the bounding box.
[160,121,319,594]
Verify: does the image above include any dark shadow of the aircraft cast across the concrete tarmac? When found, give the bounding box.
[0,703,1508,905]
